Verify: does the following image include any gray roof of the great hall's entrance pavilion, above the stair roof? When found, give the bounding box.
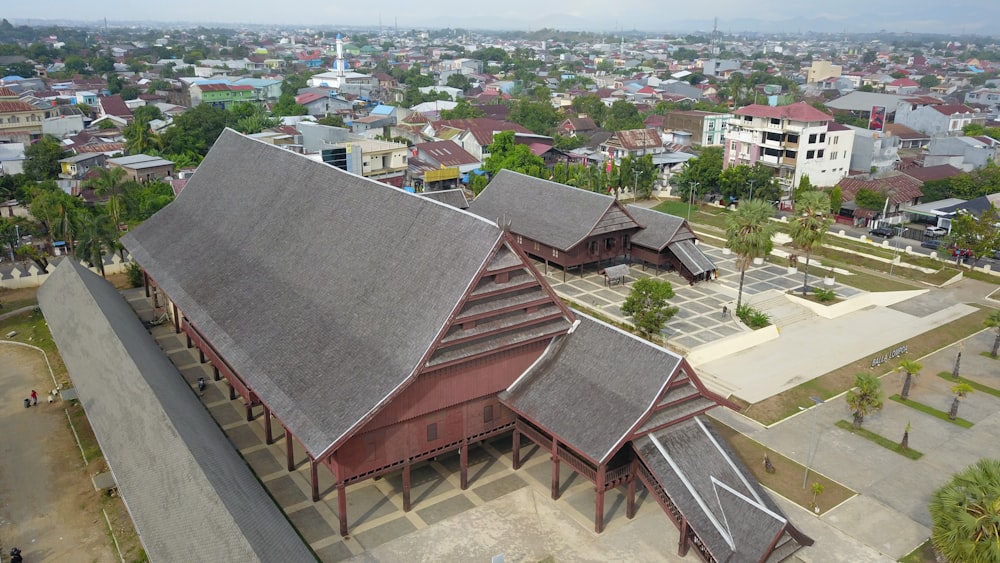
[500,313,681,461]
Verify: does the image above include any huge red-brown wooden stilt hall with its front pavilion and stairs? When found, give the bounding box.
[122,131,808,561]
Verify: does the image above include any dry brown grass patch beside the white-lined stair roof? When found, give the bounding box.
[711,419,857,514]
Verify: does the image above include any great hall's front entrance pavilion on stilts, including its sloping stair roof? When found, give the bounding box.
[500,314,813,561]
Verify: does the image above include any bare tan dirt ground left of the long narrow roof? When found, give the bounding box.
[0,344,120,563]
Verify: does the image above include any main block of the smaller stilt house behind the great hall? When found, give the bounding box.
[469,170,642,276]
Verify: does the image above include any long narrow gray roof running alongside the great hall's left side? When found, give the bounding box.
[38,259,314,561]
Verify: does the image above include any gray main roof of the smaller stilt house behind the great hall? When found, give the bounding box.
[469,170,636,251]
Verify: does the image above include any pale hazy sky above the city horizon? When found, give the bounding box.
[7,0,1000,35]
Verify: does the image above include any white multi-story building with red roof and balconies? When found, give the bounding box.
[723,102,854,199]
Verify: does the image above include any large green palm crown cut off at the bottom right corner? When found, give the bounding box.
[928,458,1000,561]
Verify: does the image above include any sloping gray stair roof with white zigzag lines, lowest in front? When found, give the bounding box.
[634,417,811,561]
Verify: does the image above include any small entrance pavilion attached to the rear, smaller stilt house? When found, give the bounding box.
[625,205,717,282]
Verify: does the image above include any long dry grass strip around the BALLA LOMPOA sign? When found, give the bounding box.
[742,307,992,425]
